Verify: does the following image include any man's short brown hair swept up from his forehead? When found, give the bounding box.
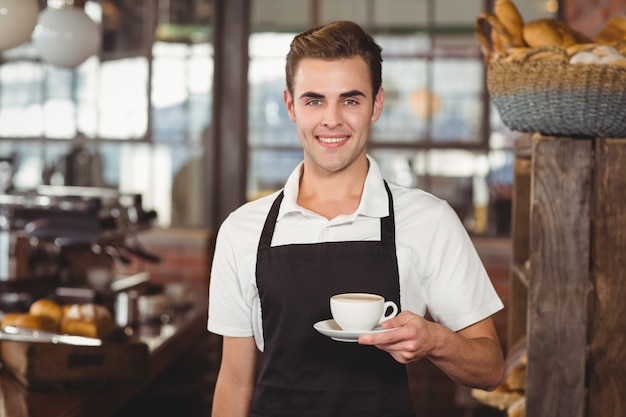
[285,20,383,96]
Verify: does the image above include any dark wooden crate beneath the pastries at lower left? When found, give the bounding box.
[0,341,149,388]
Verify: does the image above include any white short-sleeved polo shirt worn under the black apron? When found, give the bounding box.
[207,156,503,350]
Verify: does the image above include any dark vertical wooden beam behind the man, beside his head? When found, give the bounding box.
[206,0,251,230]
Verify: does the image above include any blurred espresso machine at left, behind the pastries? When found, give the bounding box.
[0,186,159,311]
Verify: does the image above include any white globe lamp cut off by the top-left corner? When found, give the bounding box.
[0,0,39,51]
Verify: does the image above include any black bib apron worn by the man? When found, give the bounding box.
[250,184,414,417]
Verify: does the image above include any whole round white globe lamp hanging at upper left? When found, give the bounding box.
[33,0,100,68]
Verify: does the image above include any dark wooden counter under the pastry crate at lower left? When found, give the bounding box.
[0,300,207,417]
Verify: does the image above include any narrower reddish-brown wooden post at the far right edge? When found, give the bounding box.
[587,139,626,417]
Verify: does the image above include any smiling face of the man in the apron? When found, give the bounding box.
[284,57,384,174]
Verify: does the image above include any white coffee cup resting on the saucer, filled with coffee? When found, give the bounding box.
[330,293,398,331]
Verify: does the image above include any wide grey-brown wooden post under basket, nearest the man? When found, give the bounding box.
[526,138,593,417]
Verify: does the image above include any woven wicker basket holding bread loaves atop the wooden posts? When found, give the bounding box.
[477,15,626,138]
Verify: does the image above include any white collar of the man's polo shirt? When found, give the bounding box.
[278,155,389,219]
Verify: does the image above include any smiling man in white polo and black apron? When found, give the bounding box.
[208,21,504,417]
